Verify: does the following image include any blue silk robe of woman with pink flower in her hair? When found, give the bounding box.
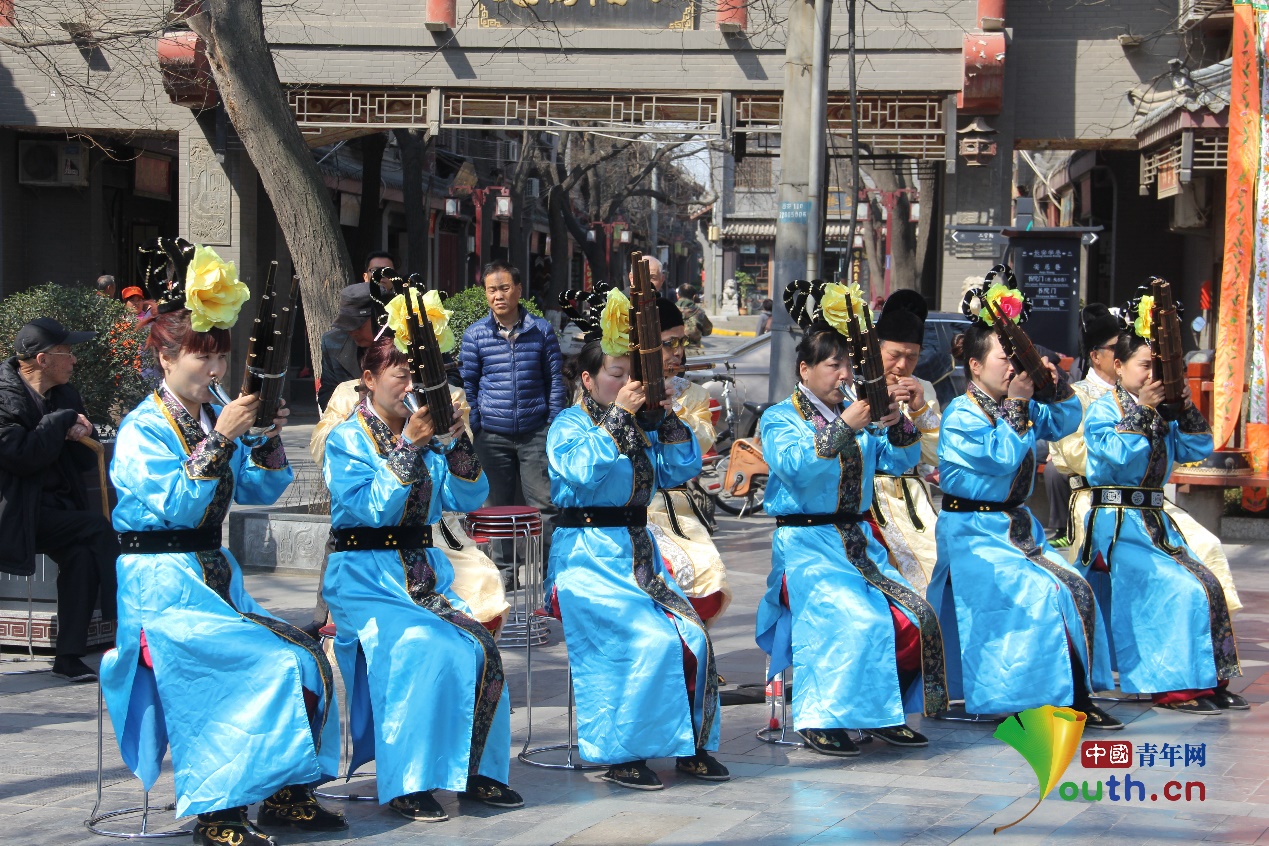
[926,384,1114,714]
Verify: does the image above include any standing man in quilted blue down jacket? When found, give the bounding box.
[458,261,565,578]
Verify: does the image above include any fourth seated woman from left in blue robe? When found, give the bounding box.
[756,284,947,757]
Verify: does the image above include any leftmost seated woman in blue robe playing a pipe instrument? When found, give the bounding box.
[102,247,346,846]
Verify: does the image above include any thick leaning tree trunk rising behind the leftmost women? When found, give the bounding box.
[189,0,354,378]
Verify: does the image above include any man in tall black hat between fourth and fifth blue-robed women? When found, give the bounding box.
[872,290,939,594]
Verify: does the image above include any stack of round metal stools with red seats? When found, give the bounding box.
[463,505,549,649]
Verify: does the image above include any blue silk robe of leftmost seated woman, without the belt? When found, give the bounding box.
[102,387,339,816]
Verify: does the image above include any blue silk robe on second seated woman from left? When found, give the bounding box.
[322,401,511,803]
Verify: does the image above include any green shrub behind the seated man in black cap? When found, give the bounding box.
[0,283,148,426]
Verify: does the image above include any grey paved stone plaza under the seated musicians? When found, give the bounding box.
[0,427,1269,846]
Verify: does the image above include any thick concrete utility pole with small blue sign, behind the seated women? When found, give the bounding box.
[766,0,822,402]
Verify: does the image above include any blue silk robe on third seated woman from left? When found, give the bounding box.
[547,394,721,764]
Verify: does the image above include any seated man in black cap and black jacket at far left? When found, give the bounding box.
[0,317,119,681]
